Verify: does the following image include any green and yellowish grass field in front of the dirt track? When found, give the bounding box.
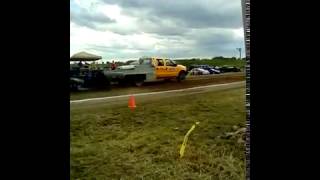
[70,88,245,180]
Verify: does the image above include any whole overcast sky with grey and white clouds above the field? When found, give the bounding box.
[70,0,244,60]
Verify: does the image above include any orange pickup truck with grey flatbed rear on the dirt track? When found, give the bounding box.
[104,57,187,86]
